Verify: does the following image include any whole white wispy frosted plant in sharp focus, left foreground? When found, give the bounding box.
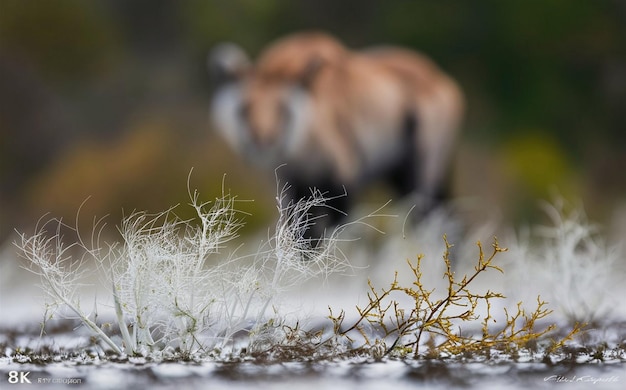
[16,183,354,355]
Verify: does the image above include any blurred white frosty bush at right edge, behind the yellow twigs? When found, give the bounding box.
[507,199,625,323]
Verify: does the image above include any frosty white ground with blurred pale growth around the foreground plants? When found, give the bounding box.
[0,197,626,389]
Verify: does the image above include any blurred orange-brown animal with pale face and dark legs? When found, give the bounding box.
[209,32,464,238]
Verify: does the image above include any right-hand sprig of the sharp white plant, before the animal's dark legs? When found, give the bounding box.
[212,186,358,350]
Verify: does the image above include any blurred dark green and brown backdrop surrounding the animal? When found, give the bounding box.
[0,0,626,244]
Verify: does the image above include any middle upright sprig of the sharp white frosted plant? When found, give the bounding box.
[106,187,242,353]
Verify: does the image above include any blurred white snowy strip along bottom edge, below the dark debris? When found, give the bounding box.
[0,352,626,390]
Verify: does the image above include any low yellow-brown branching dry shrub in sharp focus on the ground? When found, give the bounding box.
[330,237,581,359]
